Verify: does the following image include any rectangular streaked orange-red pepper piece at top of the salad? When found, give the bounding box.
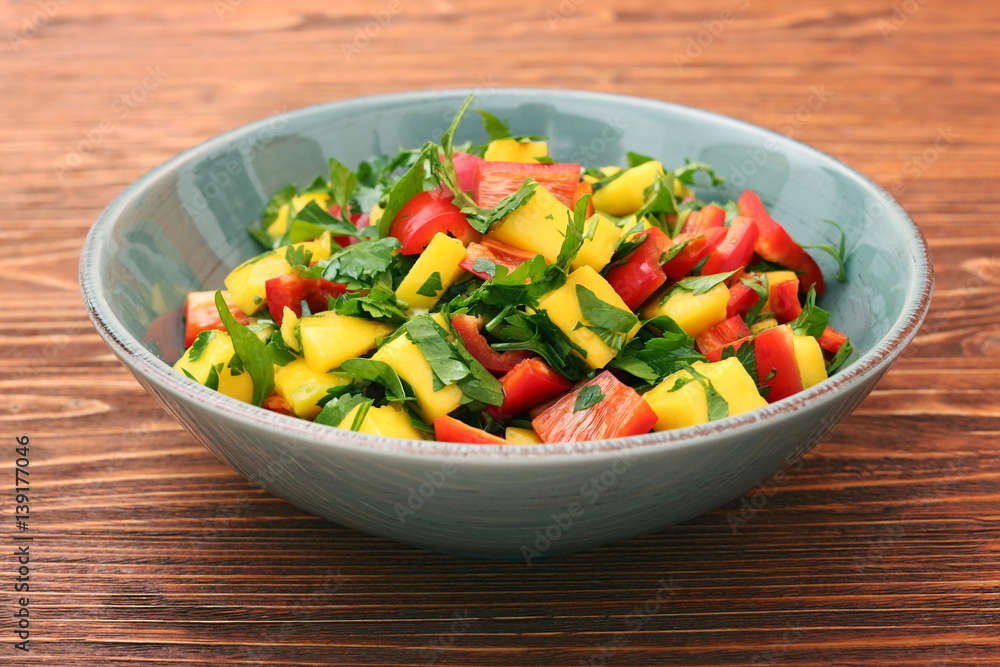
[472,160,582,208]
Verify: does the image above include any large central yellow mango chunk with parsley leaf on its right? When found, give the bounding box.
[538,266,640,368]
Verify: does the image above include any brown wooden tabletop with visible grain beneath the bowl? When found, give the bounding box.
[0,0,1000,667]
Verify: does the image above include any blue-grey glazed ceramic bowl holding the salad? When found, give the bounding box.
[81,89,933,561]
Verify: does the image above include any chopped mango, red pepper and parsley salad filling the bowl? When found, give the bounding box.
[174,98,851,445]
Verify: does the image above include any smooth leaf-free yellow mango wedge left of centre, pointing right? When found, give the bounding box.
[299,310,396,373]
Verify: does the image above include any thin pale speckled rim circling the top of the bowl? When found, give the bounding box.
[80,87,934,463]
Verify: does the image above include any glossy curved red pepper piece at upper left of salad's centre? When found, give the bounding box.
[389,190,480,255]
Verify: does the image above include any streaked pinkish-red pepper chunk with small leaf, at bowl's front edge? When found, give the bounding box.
[531,371,657,442]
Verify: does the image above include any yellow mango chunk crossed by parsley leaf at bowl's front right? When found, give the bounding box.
[643,357,767,431]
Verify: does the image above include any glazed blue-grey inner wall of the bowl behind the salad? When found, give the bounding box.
[84,89,930,420]
